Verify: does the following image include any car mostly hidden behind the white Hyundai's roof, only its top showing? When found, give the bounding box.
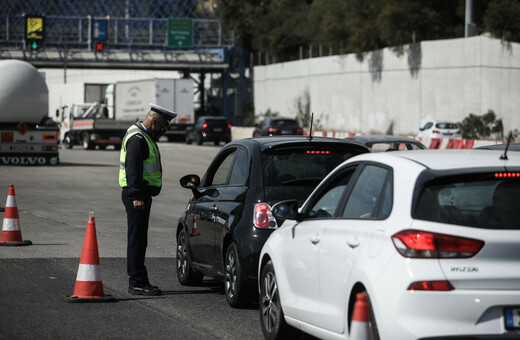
[345,135,427,152]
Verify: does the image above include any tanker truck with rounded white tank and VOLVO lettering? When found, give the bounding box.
[0,60,59,165]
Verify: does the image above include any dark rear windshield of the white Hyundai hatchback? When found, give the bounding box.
[412,172,520,230]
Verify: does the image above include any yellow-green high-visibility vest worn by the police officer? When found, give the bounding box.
[119,125,162,188]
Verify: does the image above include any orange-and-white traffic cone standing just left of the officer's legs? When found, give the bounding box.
[67,213,115,302]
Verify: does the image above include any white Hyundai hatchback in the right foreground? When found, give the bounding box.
[258,150,520,340]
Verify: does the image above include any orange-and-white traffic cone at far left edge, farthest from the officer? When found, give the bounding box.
[0,184,32,246]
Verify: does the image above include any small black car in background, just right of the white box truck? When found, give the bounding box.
[186,116,231,145]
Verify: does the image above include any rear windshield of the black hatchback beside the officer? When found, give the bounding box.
[262,146,360,204]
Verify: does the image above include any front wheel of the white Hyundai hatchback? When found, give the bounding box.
[260,261,295,340]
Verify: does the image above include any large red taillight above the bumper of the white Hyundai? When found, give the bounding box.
[392,230,484,259]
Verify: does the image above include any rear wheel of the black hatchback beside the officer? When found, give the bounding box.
[224,242,251,308]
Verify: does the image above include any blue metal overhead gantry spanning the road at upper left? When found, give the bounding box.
[0,0,233,69]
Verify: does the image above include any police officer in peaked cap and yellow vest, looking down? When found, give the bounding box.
[119,104,177,295]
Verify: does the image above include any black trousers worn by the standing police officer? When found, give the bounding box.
[121,189,152,287]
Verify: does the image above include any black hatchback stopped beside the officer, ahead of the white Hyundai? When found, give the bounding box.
[176,136,369,307]
